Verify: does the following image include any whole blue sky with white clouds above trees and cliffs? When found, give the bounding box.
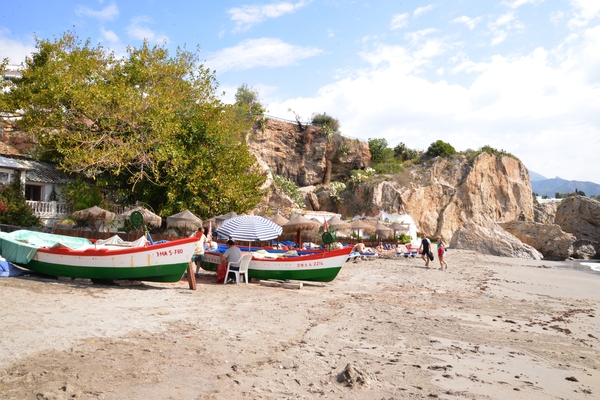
[0,0,600,183]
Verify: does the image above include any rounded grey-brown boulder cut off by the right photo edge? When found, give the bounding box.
[554,196,600,242]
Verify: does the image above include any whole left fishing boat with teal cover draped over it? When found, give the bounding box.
[0,230,199,282]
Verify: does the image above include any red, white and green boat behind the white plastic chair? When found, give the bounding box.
[201,246,352,282]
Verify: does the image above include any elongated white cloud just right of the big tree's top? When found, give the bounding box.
[206,38,323,73]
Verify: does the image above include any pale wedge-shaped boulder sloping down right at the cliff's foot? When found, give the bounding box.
[450,214,543,260]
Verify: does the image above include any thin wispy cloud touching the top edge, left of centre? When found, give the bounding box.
[227,0,312,32]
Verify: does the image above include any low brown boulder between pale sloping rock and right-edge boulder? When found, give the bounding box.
[499,221,577,260]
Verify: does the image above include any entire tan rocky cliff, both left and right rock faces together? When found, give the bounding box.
[248,120,534,244]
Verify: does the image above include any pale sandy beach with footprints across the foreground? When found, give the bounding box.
[0,250,600,400]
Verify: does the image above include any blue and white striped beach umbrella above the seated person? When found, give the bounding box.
[217,215,282,242]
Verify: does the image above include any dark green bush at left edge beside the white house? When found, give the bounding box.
[0,172,42,227]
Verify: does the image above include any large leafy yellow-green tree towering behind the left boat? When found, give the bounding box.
[1,32,265,216]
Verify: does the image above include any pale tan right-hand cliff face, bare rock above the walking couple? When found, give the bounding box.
[331,153,533,238]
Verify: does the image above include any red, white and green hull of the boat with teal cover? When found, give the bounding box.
[15,238,198,282]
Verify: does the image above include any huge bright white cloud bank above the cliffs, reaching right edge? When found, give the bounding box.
[267,26,600,181]
